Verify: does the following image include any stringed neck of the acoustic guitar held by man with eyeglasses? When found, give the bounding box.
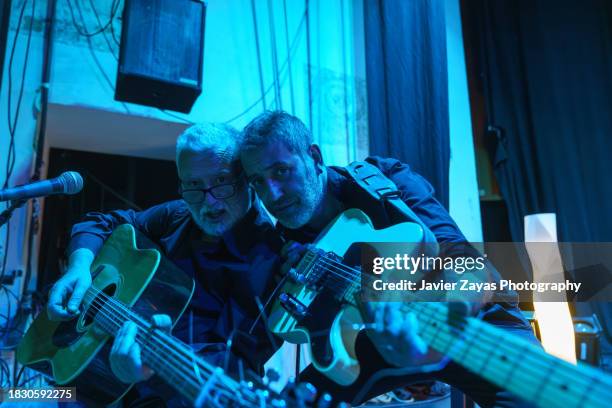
[86,292,261,407]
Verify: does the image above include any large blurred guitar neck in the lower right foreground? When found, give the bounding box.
[404,302,612,408]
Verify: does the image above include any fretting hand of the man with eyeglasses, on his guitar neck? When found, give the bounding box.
[109,314,172,384]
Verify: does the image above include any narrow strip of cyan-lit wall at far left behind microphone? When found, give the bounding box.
[0,0,46,364]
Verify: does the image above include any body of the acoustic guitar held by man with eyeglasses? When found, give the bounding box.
[17,224,194,406]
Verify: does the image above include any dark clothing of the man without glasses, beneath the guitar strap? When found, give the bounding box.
[277,157,537,406]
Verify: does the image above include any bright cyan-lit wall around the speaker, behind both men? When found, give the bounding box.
[49,0,367,163]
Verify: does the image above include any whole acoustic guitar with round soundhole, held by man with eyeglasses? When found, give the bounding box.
[17,224,316,407]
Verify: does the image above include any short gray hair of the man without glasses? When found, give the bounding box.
[242,110,312,155]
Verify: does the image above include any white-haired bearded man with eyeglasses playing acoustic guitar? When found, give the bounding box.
[48,124,280,407]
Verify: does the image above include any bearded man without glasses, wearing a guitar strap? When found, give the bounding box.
[240,111,537,407]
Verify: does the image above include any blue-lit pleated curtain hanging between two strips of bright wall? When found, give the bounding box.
[364,0,450,208]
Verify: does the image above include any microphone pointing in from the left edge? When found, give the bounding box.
[0,171,83,201]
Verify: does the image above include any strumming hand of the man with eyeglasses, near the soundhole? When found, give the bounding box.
[47,248,94,320]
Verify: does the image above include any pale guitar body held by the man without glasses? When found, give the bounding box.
[268,209,445,388]
